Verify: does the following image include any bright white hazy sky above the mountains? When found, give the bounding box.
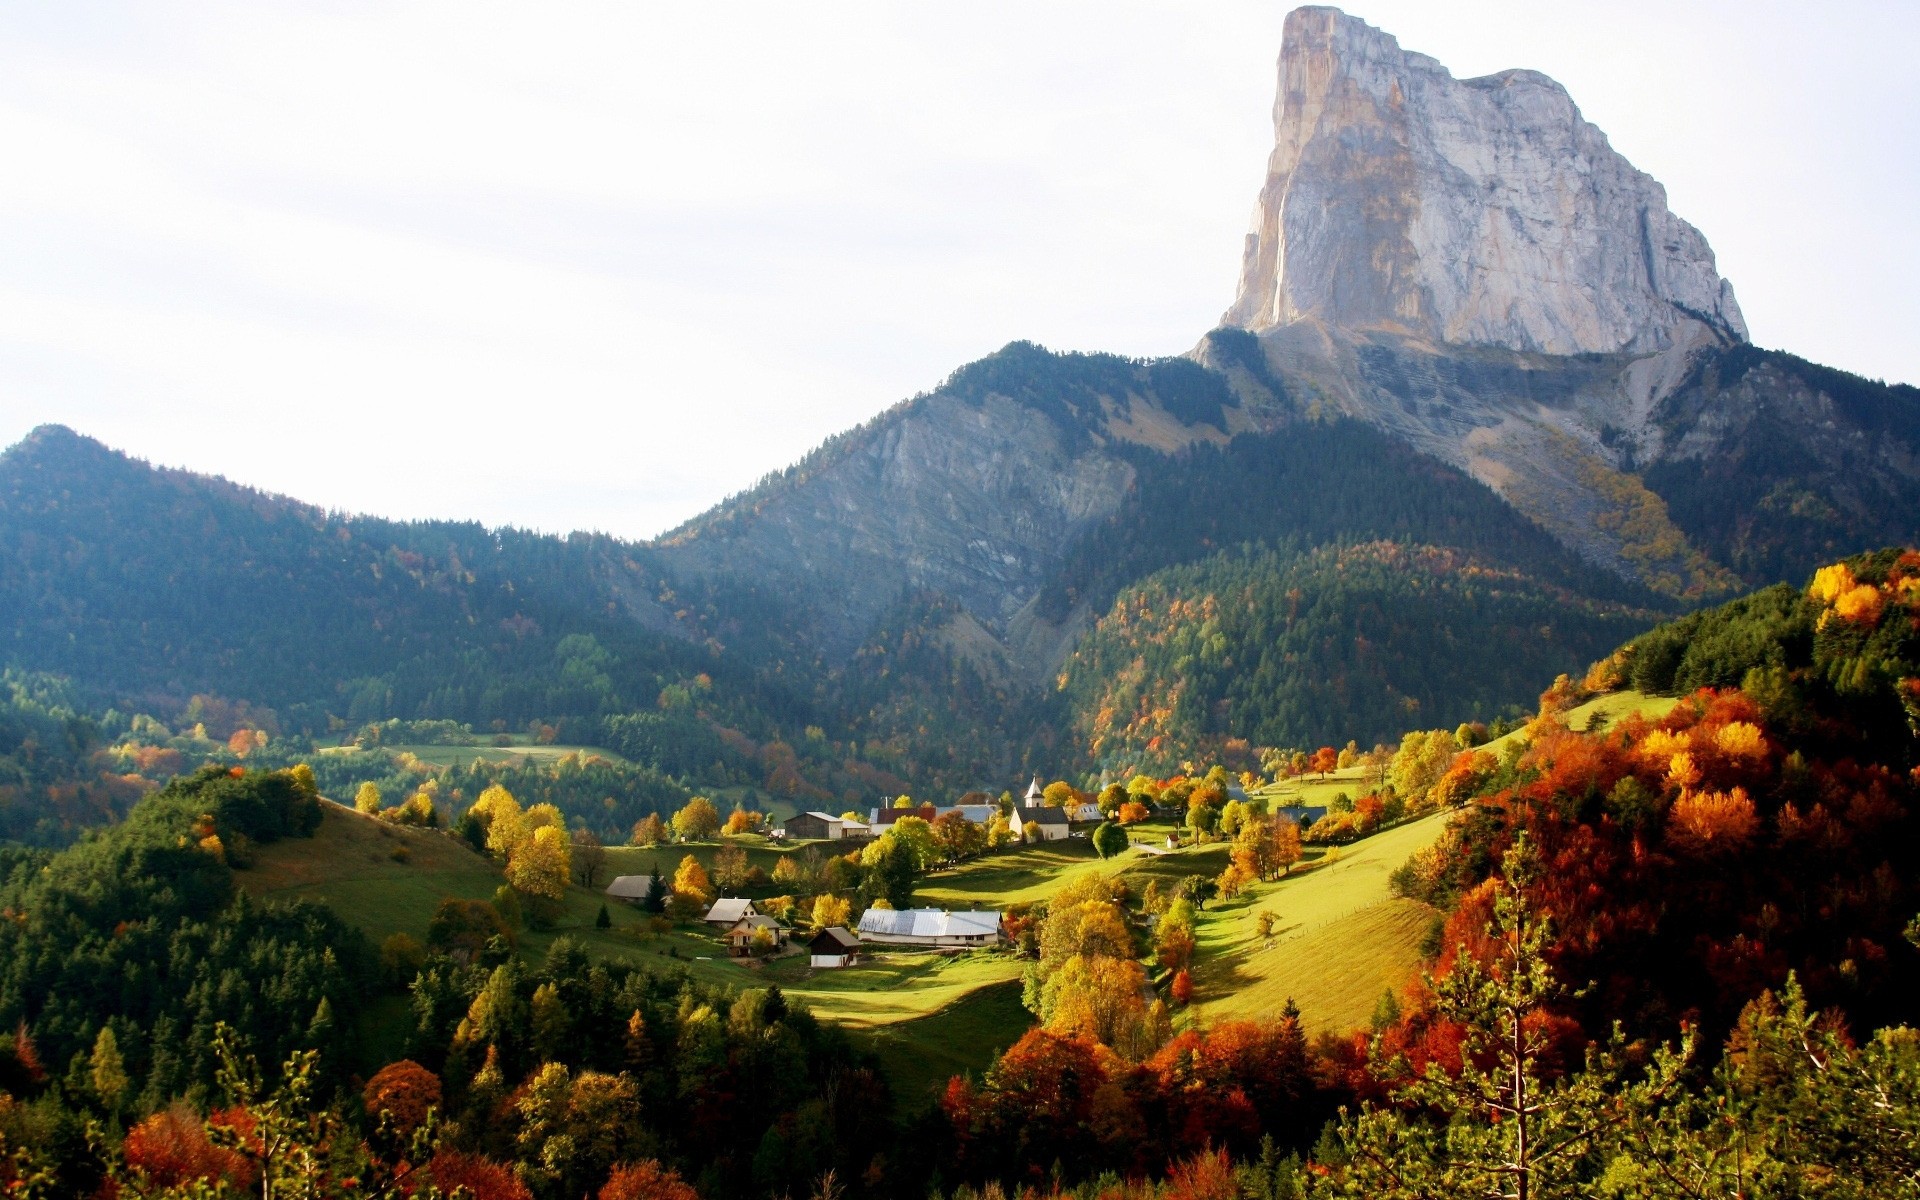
[0,0,1920,536]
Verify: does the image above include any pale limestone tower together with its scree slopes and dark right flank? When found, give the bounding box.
[1198,8,1920,603]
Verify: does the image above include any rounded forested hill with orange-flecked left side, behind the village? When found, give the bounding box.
[1062,541,1649,768]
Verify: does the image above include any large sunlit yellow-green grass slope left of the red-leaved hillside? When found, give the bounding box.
[1192,814,1446,1031]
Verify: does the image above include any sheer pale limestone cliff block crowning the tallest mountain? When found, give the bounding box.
[1223,8,1747,355]
